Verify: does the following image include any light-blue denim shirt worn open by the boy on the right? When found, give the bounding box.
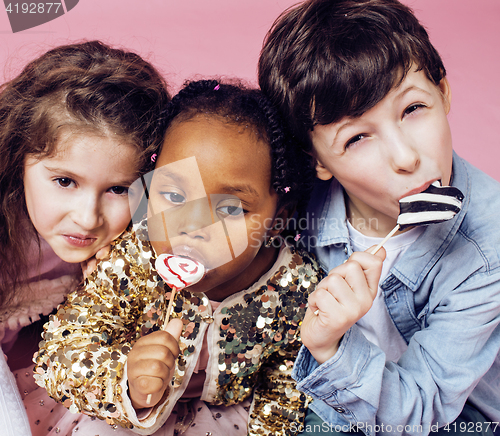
[292,154,500,436]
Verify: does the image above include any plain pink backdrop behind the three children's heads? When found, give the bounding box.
[0,0,500,181]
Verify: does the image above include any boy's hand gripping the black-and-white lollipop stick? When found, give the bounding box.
[301,247,385,364]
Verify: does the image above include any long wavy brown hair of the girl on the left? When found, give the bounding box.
[0,41,170,306]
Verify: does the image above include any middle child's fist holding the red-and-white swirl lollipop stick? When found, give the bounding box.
[127,318,182,410]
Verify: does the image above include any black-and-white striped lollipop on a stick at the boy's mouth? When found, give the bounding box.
[371,182,464,254]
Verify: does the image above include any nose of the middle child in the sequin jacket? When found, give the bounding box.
[164,197,213,239]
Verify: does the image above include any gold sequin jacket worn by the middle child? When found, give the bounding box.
[34,226,322,435]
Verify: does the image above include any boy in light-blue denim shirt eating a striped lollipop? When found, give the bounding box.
[259,0,500,435]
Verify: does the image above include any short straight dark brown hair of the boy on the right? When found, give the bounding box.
[259,0,446,149]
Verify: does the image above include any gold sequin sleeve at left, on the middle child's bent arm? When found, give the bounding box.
[35,228,172,433]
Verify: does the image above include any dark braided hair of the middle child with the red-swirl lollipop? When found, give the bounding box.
[158,80,314,213]
